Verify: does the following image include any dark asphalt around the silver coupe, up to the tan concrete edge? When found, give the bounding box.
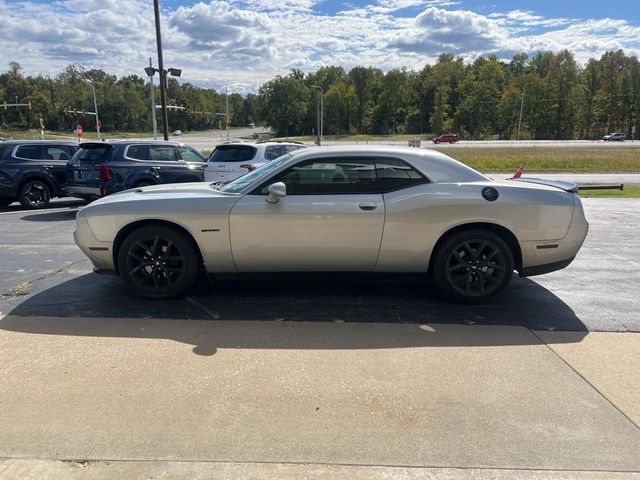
[0,199,640,331]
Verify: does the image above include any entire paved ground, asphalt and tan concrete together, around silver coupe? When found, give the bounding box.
[0,199,640,480]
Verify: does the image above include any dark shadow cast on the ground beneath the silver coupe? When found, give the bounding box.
[0,274,587,355]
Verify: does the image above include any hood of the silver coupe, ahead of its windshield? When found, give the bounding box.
[91,182,238,205]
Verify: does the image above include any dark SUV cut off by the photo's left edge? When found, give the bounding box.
[0,140,78,209]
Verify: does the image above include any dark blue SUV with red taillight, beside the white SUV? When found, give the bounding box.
[65,140,206,200]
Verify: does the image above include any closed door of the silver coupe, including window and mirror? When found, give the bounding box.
[230,158,385,272]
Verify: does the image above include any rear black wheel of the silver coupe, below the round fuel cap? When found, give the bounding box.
[433,230,513,303]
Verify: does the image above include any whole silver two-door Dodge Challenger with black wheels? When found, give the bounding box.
[74,146,588,303]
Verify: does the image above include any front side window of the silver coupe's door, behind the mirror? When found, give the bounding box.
[259,158,379,195]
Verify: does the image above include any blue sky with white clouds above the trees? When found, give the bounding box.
[0,0,640,93]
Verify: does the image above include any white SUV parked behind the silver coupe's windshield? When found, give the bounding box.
[204,141,306,183]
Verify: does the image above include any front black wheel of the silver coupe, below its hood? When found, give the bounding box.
[118,226,199,299]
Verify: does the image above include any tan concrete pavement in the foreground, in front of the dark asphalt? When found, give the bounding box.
[0,316,640,479]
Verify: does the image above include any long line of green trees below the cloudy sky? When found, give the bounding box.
[0,50,640,139]
